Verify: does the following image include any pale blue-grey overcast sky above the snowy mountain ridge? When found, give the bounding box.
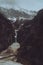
[0,0,43,10]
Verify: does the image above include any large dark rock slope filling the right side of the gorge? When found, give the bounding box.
[17,9,43,65]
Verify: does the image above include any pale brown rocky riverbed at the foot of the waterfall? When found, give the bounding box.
[0,42,22,65]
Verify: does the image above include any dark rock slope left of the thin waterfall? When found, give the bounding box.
[0,13,14,52]
